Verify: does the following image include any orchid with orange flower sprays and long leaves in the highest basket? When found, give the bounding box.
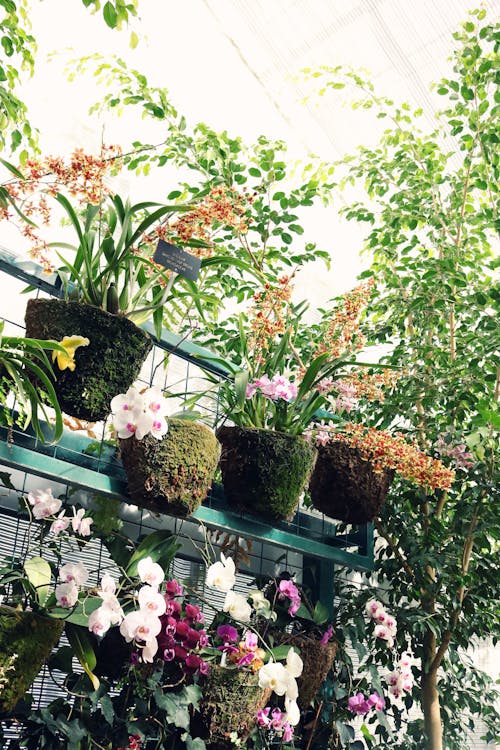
[0,151,221,336]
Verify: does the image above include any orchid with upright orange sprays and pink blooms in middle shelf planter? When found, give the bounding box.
[193,276,400,435]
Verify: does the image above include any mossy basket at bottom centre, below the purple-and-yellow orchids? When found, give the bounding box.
[193,665,272,750]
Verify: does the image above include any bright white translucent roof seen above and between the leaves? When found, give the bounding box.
[4,0,500,300]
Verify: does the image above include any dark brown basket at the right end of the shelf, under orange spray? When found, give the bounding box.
[309,442,394,523]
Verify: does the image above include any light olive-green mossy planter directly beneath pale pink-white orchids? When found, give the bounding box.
[120,419,220,518]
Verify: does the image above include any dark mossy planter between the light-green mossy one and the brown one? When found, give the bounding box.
[217,427,316,520]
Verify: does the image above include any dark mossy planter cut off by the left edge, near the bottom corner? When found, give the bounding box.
[0,607,64,714]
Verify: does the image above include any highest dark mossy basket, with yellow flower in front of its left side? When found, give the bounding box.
[25,299,153,422]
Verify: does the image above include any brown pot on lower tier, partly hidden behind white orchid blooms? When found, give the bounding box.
[275,633,337,711]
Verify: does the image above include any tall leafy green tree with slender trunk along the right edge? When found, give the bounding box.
[304,11,500,750]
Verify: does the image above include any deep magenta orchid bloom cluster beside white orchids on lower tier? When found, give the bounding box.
[150,579,210,674]
